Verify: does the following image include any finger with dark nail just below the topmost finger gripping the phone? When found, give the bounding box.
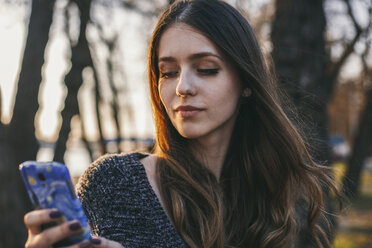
[38,220,82,247]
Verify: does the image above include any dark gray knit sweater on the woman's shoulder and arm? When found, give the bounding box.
[77,153,187,248]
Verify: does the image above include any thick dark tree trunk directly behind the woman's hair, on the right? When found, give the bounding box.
[271,0,333,247]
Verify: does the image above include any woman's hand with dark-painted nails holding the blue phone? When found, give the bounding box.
[24,209,89,248]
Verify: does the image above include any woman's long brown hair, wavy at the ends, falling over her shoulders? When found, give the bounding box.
[148,0,333,248]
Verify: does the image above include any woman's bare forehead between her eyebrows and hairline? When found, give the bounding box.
[158,23,221,58]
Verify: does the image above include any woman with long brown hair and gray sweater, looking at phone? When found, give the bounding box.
[21,0,333,248]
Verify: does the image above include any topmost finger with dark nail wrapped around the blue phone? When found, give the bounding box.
[24,209,63,234]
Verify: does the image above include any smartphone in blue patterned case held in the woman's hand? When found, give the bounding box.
[19,161,91,247]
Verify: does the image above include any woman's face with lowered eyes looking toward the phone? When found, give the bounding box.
[158,23,242,142]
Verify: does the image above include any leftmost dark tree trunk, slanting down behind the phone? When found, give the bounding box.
[0,0,55,247]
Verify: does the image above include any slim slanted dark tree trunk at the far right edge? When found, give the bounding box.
[343,85,372,198]
